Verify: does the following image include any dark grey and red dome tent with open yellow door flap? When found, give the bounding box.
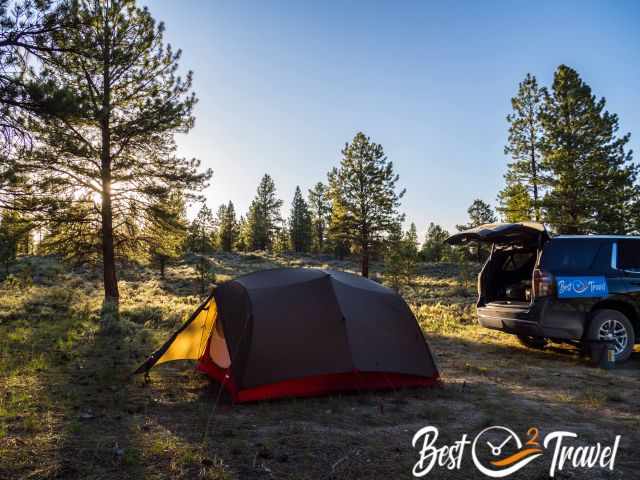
[136,268,438,402]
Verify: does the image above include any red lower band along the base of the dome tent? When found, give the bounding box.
[197,354,439,403]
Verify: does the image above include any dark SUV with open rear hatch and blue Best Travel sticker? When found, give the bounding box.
[447,222,640,362]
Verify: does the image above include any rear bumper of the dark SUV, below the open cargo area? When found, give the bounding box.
[478,299,586,340]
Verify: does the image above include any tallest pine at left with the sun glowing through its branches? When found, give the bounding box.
[17,0,211,301]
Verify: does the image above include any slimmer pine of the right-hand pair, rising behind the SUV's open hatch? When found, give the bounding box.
[498,73,546,222]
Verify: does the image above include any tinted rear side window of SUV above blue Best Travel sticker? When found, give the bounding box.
[540,238,609,271]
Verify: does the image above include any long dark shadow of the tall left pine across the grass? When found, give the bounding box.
[46,305,147,479]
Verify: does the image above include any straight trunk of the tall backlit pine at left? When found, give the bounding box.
[100,16,120,303]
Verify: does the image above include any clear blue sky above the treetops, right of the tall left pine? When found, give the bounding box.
[146,0,640,238]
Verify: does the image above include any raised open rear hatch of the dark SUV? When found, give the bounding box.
[446,222,549,247]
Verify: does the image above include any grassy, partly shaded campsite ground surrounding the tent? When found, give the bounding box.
[0,255,640,480]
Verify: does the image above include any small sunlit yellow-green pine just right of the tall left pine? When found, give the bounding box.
[144,191,187,278]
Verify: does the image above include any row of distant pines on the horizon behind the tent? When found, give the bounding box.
[180,132,404,276]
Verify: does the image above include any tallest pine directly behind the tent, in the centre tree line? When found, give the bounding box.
[329,132,404,277]
